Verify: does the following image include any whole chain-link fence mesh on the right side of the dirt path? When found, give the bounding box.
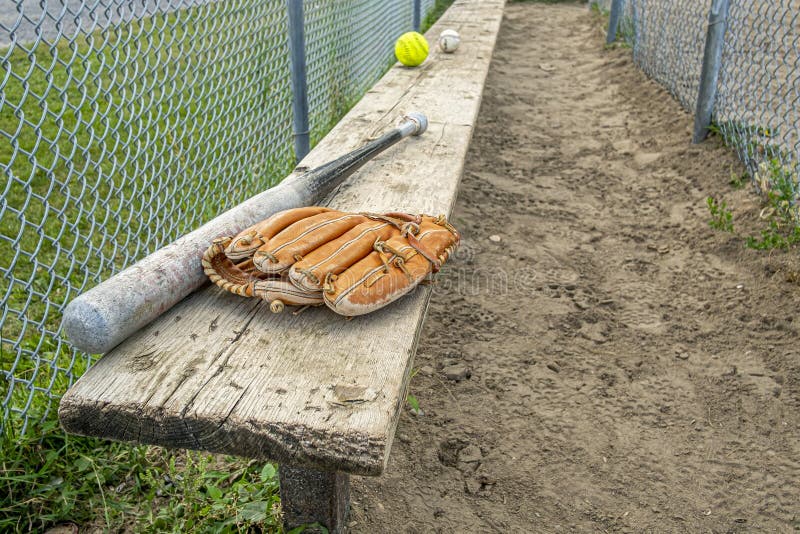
[596,0,800,207]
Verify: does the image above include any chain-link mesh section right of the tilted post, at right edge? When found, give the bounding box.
[714,0,800,197]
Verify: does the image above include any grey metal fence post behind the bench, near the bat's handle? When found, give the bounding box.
[286,0,310,161]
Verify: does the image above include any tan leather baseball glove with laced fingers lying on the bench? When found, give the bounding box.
[203,206,460,316]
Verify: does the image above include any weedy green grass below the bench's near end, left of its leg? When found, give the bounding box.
[0,419,280,532]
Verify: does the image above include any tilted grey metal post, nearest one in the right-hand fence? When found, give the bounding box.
[692,0,729,143]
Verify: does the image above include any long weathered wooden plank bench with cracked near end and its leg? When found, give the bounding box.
[59,0,504,532]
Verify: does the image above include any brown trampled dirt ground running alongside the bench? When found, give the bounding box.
[351,3,800,533]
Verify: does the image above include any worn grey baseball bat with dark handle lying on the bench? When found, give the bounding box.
[62,113,428,354]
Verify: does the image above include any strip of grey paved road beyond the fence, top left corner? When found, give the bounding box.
[0,0,214,47]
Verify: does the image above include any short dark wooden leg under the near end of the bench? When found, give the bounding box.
[278,465,350,534]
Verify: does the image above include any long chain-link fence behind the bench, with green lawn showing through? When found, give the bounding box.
[0,0,446,438]
